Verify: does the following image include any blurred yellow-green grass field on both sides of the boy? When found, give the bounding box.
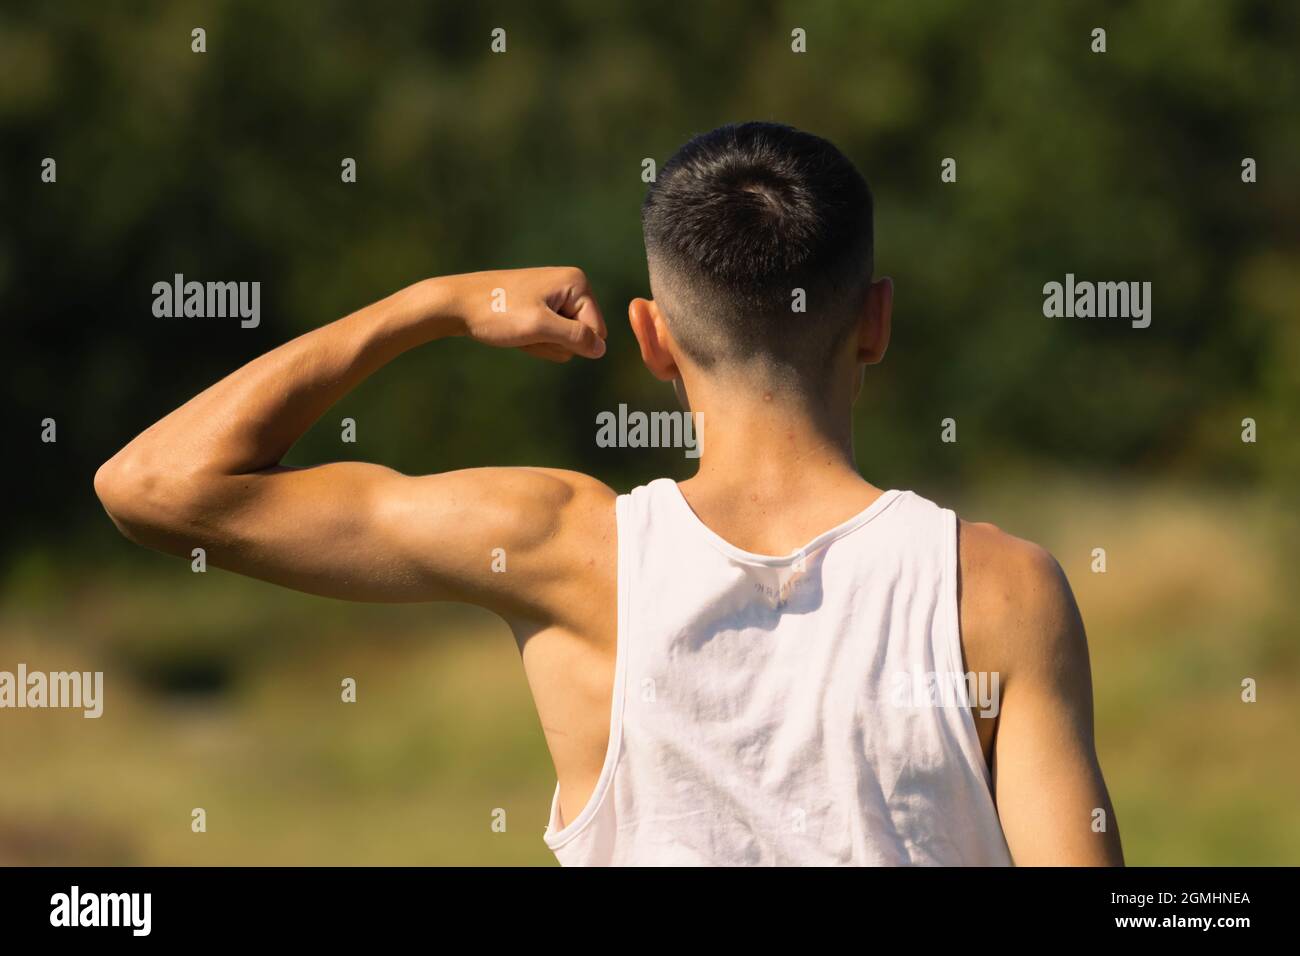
[0,479,1300,865]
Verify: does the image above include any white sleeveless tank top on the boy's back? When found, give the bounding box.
[545,479,1010,866]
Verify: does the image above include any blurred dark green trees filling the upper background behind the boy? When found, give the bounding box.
[0,0,1300,555]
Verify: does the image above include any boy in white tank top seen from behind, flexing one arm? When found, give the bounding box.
[95,122,1122,865]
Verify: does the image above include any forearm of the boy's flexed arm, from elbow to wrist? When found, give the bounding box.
[104,278,455,479]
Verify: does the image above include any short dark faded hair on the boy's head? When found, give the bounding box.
[641,122,872,381]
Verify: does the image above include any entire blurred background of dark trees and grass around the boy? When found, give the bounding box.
[0,0,1300,865]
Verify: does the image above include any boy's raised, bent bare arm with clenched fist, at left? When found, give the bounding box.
[95,268,612,617]
